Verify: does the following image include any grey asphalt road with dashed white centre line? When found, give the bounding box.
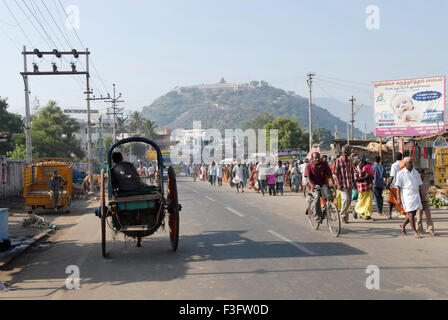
[0,177,448,299]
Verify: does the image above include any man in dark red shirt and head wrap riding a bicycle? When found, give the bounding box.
[305,152,336,223]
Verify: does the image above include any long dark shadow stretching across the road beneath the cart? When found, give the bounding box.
[1,230,365,290]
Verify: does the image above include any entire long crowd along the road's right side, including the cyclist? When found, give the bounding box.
[186,146,436,238]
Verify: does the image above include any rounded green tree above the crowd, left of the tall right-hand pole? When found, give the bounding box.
[264,117,308,149]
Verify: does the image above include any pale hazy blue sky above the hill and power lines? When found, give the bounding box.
[0,0,448,130]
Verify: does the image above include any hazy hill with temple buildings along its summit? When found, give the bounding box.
[142,82,362,138]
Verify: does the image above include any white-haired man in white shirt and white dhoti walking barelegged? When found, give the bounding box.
[395,157,423,238]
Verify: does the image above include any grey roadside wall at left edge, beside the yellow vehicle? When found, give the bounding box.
[0,160,25,199]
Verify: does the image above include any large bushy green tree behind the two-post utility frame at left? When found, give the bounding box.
[13,100,85,158]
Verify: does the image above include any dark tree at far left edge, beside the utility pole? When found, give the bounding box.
[0,97,24,154]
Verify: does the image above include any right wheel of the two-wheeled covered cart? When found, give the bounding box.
[167,166,179,251]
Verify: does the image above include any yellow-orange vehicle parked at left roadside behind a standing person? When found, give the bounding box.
[23,158,73,213]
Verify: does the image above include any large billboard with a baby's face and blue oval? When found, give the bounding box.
[373,76,445,136]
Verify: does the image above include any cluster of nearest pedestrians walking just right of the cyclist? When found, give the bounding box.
[331,146,436,238]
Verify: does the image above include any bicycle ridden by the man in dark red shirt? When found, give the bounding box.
[305,186,341,237]
